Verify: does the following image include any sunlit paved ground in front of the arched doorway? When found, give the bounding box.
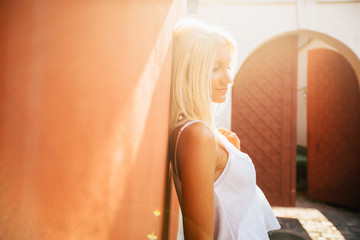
[270,194,360,240]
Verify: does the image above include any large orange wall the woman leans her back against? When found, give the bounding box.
[0,0,185,240]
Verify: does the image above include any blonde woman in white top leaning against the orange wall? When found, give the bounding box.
[169,19,280,240]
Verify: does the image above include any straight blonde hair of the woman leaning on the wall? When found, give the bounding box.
[170,18,235,133]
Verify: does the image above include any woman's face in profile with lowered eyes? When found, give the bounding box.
[212,44,233,103]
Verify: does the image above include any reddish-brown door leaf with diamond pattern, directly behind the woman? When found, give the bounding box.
[231,35,298,206]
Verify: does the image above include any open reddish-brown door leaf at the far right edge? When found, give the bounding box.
[308,49,360,208]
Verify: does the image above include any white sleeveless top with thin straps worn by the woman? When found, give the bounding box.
[173,121,280,240]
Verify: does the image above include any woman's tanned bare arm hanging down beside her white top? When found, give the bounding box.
[177,123,217,240]
